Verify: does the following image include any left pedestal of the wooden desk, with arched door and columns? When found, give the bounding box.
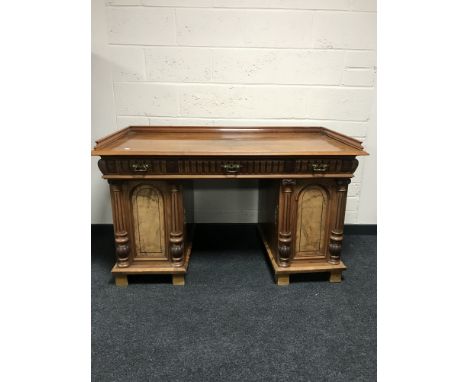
[109,180,192,286]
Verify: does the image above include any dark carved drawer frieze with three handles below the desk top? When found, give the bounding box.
[98,157,357,175]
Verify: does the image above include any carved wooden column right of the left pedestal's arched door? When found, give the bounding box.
[169,185,184,267]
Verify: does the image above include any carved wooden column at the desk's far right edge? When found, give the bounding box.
[328,179,351,264]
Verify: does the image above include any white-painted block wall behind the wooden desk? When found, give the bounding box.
[92,0,376,223]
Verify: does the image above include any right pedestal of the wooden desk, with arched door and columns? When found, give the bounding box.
[259,178,350,285]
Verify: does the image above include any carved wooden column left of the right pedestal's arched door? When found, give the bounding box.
[278,179,296,267]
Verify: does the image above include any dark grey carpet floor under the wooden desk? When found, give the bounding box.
[92,225,377,382]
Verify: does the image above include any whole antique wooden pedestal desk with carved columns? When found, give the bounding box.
[92,126,367,285]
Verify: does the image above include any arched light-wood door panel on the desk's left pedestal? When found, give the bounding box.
[131,184,168,260]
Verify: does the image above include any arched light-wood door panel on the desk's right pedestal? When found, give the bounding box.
[294,184,330,260]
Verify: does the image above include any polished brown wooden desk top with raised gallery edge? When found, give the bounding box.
[92,126,368,157]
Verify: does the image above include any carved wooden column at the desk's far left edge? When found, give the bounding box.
[109,181,130,268]
